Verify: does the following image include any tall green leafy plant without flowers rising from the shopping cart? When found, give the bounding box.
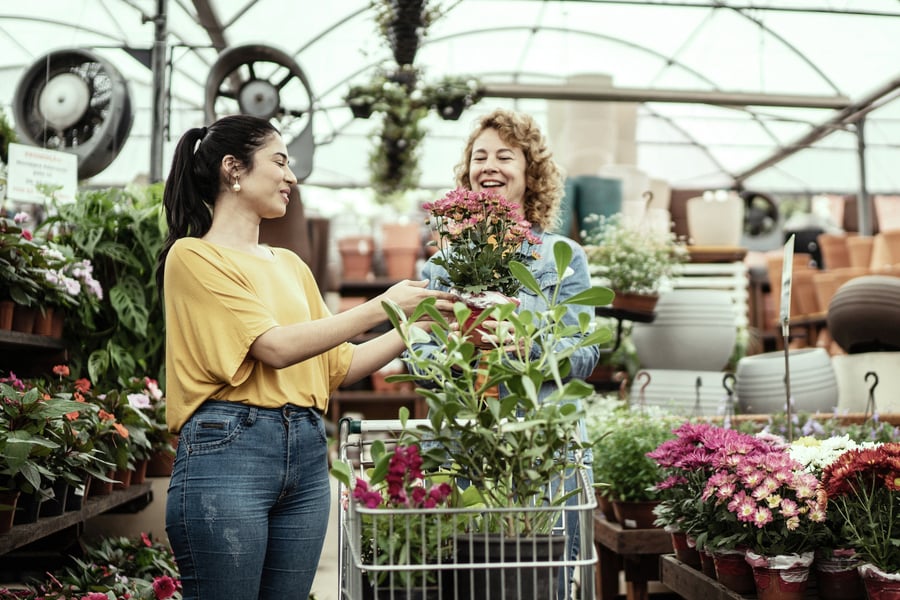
[385,243,612,534]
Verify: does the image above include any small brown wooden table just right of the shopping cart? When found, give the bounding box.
[594,511,672,600]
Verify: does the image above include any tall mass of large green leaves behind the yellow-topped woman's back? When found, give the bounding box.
[41,184,165,387]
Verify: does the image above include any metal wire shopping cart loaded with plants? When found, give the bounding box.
[338,419,597,600]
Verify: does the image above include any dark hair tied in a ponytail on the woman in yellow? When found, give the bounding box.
[156,115,279,296]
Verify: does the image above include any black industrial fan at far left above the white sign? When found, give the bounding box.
[13,49,134,179]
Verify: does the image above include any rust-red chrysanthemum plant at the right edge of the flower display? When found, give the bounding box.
[822,442,900,580]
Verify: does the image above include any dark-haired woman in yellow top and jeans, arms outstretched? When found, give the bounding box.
[156,115,454,600]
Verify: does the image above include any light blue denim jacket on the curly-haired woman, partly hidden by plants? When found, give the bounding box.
[416,232,600,462]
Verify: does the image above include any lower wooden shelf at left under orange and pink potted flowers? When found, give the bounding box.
[0,482,153,555]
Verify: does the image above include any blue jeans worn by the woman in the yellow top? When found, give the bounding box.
[166,400,331,600]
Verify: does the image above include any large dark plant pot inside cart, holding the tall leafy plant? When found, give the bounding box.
[456,533,566,600]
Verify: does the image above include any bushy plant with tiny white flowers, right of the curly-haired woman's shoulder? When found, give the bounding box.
[581,213,690,306]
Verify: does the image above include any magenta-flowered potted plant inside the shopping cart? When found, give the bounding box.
[331,440,462,598]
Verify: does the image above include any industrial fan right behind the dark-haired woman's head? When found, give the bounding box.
[204,44,315,181]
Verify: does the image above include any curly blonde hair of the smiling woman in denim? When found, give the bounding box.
[454,108,564,231]
